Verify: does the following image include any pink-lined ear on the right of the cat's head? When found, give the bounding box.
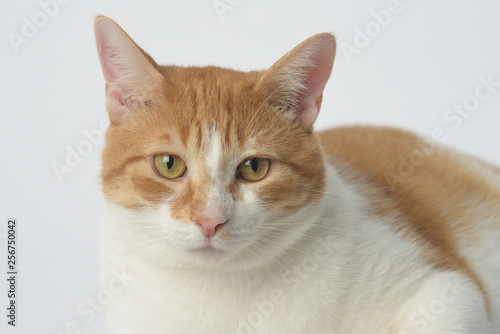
[255,33,336,130]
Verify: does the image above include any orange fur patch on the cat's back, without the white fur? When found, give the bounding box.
[319,126,500,312]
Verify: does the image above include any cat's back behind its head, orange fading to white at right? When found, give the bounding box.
[318,126,500,324]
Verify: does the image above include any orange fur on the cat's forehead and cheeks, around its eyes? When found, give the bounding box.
[102,66,325,218]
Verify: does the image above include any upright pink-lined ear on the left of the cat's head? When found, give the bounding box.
[94,16,165,123]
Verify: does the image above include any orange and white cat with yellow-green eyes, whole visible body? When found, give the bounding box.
[95,16,500,334]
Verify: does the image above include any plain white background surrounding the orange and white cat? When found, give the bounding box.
[0,0,500,334]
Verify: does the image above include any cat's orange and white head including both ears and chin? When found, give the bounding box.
[95,16,335,266]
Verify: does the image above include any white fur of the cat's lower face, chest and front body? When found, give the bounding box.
[102,148,500,334]
